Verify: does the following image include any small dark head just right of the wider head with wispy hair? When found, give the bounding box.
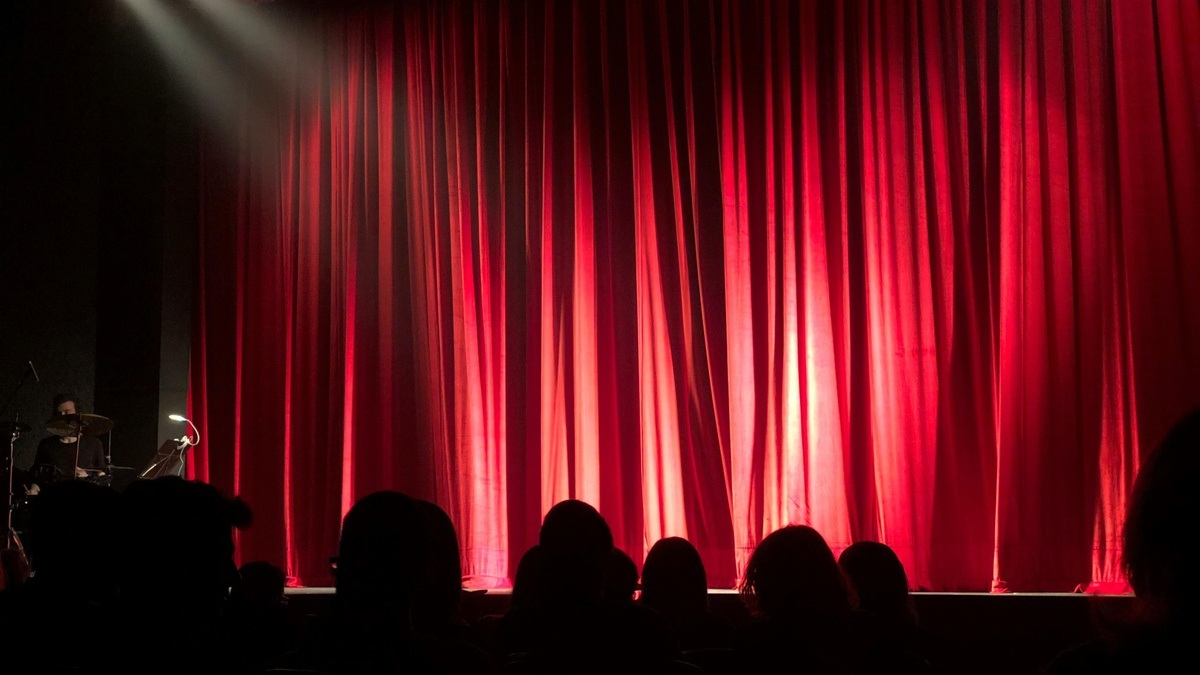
[838,542,917,623]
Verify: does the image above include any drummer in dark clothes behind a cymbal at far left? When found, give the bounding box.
[29,393,113,495]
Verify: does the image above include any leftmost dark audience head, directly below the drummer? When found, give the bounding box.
[24,480,119,592]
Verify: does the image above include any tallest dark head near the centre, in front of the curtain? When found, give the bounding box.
[538,500,612,599]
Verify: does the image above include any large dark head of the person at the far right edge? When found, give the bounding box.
[1123,410,1200,620]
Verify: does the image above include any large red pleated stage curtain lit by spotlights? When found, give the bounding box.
[191,0,1200,591]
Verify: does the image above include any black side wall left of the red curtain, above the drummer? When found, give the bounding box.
[0,0,194,485]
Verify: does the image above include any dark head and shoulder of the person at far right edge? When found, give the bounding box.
[1044,410,1200,675]
